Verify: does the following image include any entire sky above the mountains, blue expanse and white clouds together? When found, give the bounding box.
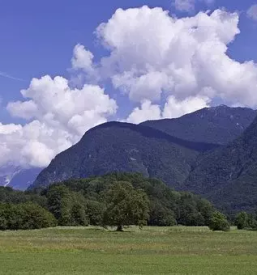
[0,0,257,167]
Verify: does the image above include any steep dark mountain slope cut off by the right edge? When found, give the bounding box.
[183,115,257,215]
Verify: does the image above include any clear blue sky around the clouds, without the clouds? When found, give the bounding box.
[0,0,257,122]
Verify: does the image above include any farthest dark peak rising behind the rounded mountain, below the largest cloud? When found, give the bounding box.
[141,105,257,145]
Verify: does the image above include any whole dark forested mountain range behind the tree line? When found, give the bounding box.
[31,105,257,211]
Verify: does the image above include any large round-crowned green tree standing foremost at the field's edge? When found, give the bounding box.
[104,181,149,231]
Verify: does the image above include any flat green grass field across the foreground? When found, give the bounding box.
[0,227,257,275]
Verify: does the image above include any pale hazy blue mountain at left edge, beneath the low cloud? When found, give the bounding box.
[0,164,42,190]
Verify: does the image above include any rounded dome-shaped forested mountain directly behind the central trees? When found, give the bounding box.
[31,122,217,191]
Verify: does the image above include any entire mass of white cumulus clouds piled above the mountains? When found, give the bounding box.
[0,5,257,167]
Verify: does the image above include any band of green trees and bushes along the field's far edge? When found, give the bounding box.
[0,173,254,231]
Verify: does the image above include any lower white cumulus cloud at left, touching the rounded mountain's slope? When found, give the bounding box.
[0,76,117,167]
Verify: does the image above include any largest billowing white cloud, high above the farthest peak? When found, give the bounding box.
[97,6,257,107]
